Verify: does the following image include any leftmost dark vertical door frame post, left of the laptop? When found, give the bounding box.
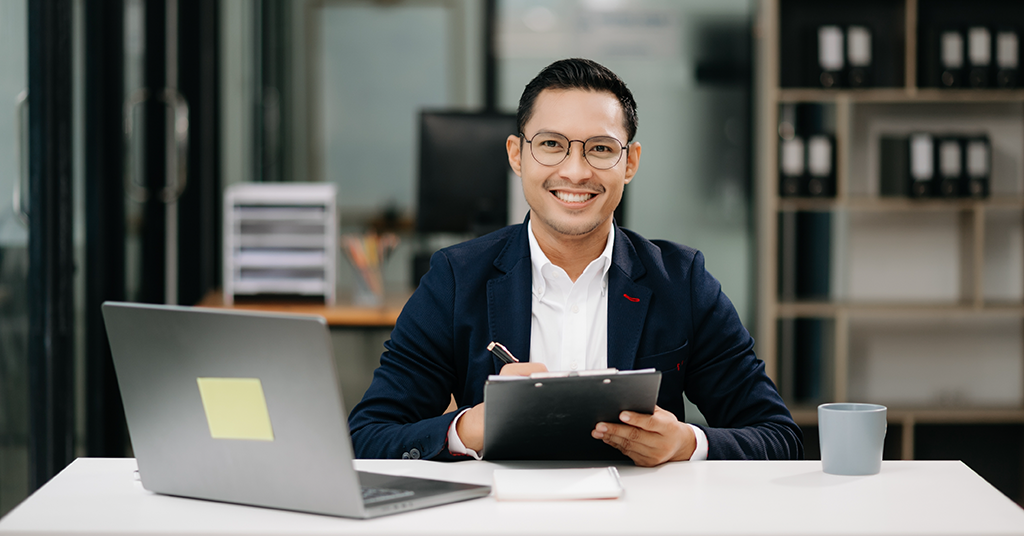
[29,0,75,490]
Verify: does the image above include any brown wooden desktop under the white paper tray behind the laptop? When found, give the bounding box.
[196,290,410,328]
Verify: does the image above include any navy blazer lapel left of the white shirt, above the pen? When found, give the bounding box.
[487,216,534,374]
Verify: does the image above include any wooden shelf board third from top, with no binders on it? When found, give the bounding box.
[776,301,1024,319]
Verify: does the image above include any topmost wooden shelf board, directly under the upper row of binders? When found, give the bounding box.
[778,87,1024,104]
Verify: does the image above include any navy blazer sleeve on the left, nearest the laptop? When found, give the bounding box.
[348,252,468,460]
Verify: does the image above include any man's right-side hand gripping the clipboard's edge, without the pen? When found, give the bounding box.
[593,406,697,467]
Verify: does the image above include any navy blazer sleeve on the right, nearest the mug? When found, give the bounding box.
[685,252,804,459]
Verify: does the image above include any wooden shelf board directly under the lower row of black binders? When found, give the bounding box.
[778,196,1024,212]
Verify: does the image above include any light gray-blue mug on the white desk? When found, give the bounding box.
[818,403,886,476]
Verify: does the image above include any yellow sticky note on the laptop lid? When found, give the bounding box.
[196,378,273,441]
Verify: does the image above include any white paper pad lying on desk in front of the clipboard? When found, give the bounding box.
[494,467,623,500]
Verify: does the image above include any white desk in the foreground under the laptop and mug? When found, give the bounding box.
[0,458,1024,536]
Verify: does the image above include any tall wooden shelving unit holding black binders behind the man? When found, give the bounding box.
[755,0,1024,481]
